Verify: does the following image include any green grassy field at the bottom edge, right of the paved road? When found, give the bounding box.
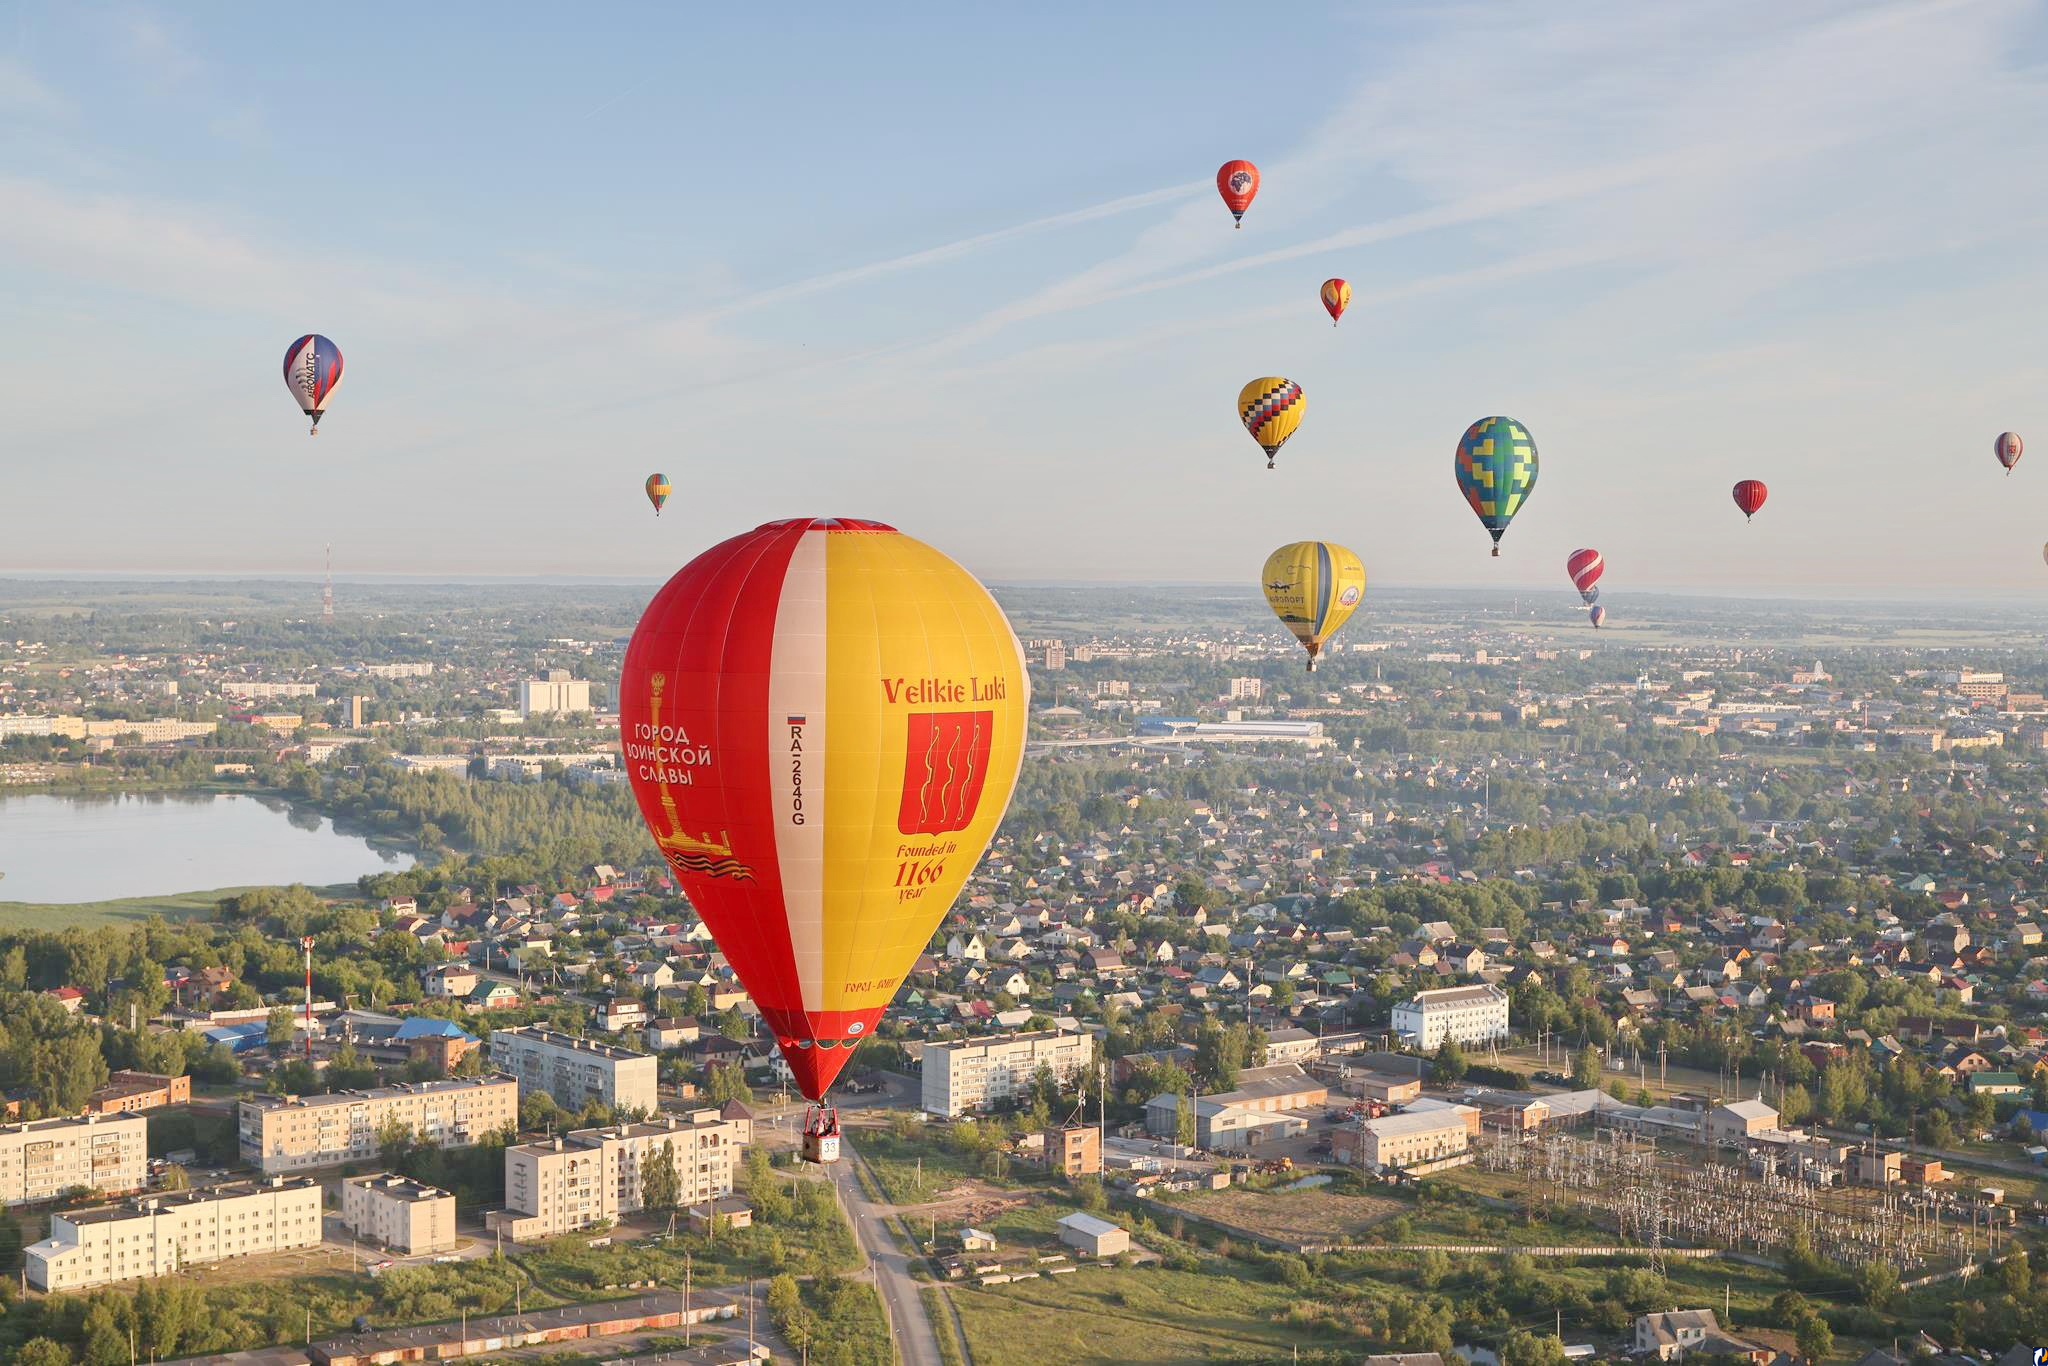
[948,1262,1360,1366]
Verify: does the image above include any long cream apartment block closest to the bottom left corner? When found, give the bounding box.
[25,1176,322,1290]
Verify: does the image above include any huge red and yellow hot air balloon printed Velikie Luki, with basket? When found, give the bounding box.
[618,518,1030,1157]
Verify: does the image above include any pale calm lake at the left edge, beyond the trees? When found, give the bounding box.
[0,795,414,903]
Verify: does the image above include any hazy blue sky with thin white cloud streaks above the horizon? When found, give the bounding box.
[0,0,2048,596]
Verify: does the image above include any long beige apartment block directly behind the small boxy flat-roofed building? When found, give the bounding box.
[242,1077,518,1176]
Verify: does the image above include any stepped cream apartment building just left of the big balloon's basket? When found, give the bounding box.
[483,1110,743,1243]
